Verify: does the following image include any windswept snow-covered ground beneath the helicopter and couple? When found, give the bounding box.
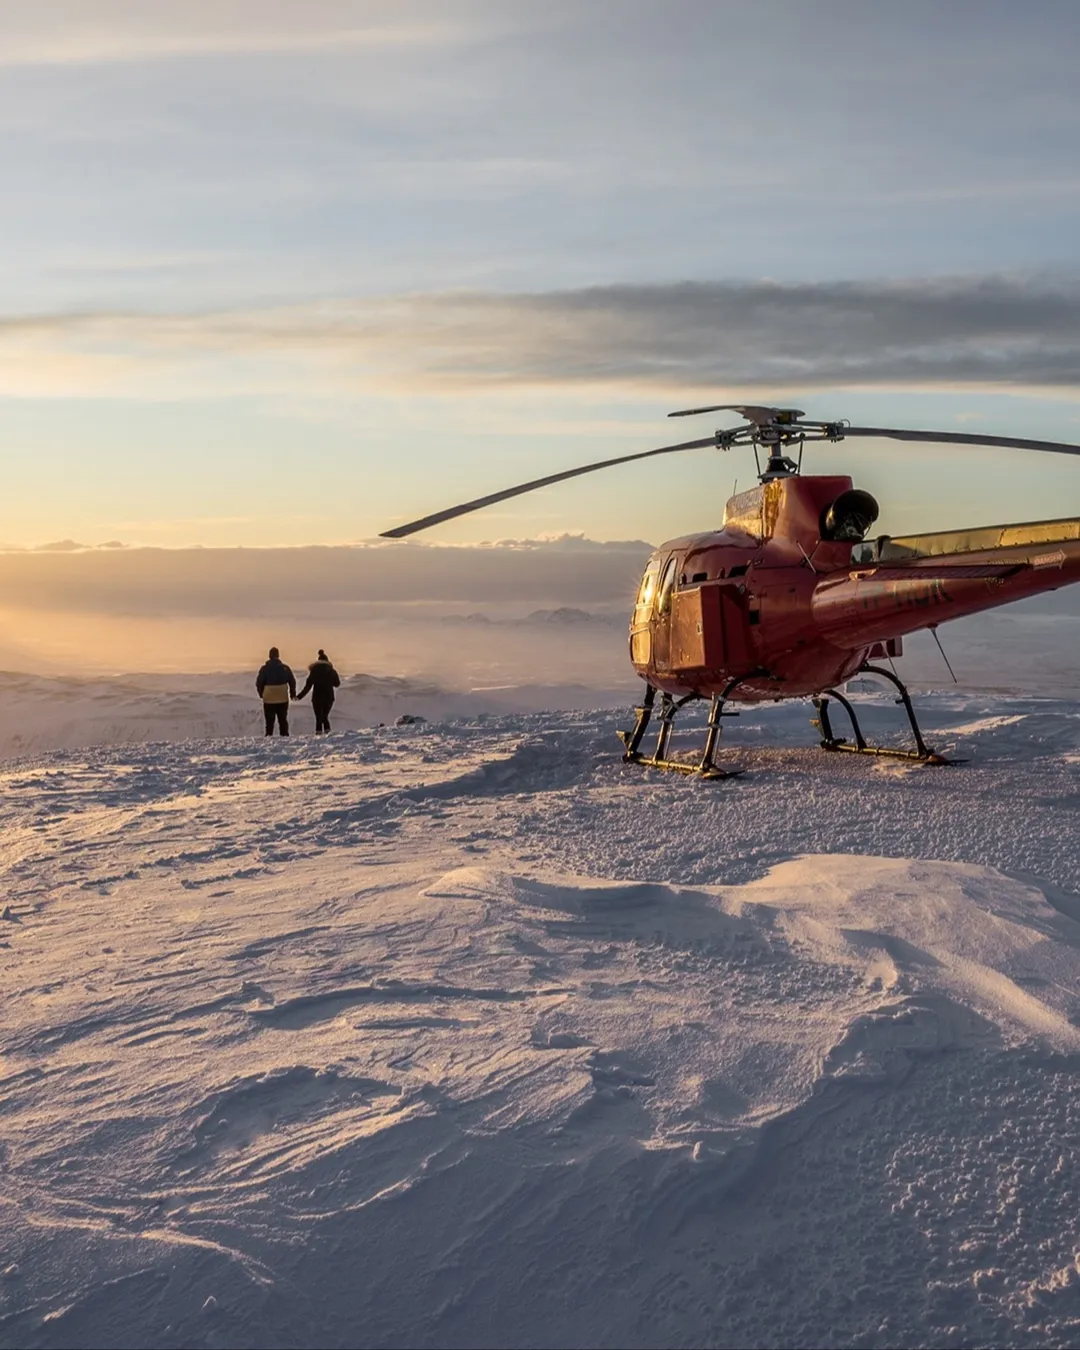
[0,695,1080,1347]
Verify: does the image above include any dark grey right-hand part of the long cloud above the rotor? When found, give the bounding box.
[353,277,1080,387]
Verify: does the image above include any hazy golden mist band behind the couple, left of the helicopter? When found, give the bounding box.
[0,537,649,687]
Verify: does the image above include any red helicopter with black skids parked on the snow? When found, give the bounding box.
[382,404,1080,778]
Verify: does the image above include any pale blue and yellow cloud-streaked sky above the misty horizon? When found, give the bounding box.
[0,0,1080,548]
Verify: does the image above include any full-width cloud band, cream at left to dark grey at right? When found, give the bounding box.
[0,275,1080,397]
